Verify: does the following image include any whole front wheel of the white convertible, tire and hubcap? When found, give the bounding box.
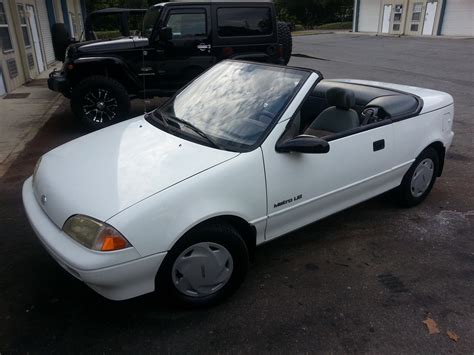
[155,224,249,308]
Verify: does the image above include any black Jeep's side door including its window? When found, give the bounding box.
[154,5,215,89]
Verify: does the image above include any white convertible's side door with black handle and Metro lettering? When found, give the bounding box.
[262,114,396,240]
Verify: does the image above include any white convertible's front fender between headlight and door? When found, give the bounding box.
[107,148,267,257]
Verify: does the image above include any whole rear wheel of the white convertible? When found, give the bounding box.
[394,147,439,207]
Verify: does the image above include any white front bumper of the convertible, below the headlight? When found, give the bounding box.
[23,177,166,300]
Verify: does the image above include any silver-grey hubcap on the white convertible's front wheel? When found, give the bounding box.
[171,242,234,297]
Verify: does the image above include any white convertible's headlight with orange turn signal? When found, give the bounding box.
[63,215,131,251]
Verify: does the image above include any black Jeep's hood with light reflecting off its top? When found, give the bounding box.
[72,37,148,54]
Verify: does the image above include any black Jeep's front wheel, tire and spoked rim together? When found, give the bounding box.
[71,75,130,131]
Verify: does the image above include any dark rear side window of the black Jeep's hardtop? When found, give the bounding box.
[217,7,272,37]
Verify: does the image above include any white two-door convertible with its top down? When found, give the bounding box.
[23,61,454,306]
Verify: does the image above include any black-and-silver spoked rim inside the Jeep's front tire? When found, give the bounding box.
[83,89,118,123]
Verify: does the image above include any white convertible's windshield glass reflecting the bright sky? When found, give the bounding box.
[155,61,309,151]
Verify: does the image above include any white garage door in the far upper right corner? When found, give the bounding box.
[442,0,474,36]
